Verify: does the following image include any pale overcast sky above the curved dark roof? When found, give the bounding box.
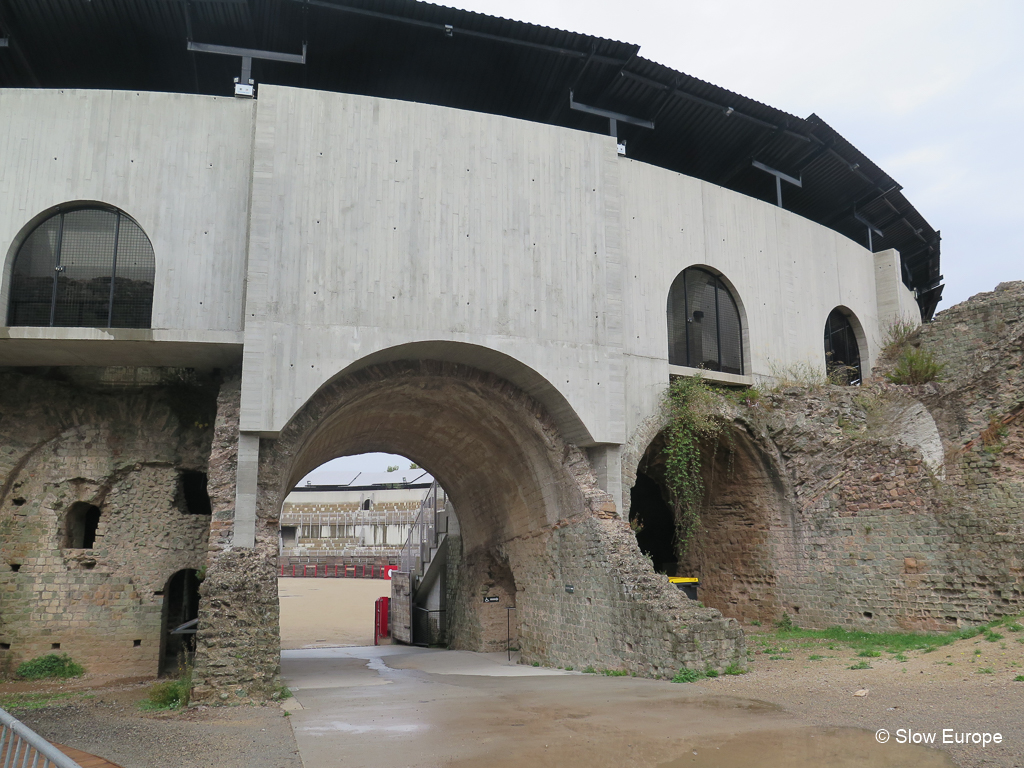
[315,0,1024,471]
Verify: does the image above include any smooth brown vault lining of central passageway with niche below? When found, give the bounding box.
[260,360,603,650]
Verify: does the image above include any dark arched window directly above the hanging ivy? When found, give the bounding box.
[669,266,743,374]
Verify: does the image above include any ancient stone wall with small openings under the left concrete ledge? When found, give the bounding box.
[0,369,223,675]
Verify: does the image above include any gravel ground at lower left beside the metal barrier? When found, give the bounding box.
[2,679,302,768]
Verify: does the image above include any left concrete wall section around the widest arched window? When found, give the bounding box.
[0,89,255,335]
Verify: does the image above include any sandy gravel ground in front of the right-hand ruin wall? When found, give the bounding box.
[698,630,1024,768]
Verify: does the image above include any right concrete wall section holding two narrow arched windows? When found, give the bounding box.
[618,159,884,434]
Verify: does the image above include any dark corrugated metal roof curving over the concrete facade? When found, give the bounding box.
[0,0,942,319]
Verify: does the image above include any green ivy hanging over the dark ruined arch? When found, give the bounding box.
[664,376,723,555]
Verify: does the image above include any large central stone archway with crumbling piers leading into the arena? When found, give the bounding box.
[190,359,745,698]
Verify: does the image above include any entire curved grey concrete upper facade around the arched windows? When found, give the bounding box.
[0,86,920,528]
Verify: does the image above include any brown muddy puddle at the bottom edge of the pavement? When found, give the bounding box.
[658,728,956,768]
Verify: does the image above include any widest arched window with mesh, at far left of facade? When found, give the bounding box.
[7,206,156,328]
